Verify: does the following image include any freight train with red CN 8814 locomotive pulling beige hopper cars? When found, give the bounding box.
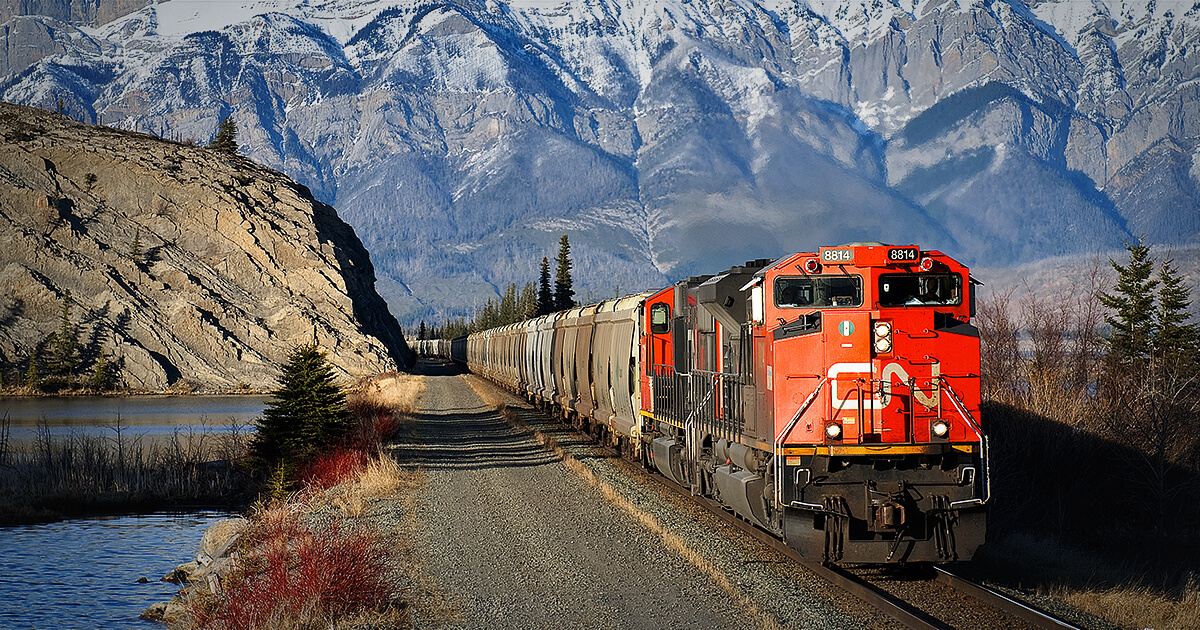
[418,242,990,564]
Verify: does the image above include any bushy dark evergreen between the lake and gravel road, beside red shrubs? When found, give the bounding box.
[251,344,350,467]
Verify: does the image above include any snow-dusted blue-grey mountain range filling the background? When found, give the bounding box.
[0,0,1200,323]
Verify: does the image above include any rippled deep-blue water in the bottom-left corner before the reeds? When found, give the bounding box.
[0,512,228,629]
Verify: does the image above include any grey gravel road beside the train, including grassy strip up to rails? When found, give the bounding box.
[396,357,892,629]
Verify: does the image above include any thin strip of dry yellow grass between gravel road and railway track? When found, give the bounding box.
[463,376,780,630]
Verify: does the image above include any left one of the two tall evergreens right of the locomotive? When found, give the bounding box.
[1099,240,1158,366]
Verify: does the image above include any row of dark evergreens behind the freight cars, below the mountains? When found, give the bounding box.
[416,234,578,340]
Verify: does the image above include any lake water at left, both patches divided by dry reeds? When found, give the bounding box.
[0,396,266,629]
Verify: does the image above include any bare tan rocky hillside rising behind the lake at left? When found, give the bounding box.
[0,103,410,390]
